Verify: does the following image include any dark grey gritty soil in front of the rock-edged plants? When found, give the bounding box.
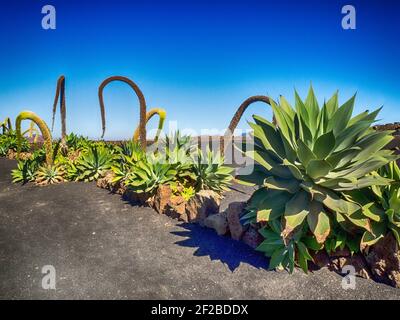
[0,159,400,300]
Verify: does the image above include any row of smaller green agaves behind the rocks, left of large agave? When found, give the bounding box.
[5,122,233,197]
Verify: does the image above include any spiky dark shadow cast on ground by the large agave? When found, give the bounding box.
[171,223,269,272]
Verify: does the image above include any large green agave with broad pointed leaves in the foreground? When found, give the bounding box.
[237,88,396,270]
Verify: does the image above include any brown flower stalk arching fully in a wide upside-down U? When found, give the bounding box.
[99,76,146,149]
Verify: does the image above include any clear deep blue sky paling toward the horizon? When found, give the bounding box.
[0,0,400,139]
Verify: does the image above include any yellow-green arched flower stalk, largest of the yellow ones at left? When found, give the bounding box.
[15,111,53,166]
